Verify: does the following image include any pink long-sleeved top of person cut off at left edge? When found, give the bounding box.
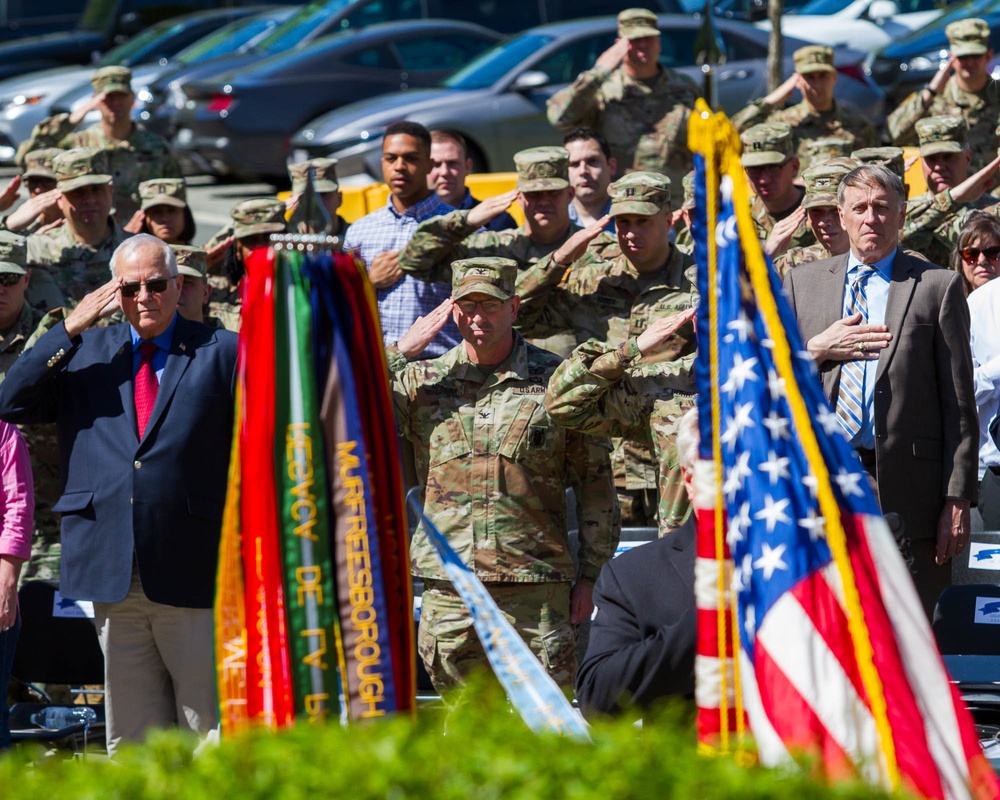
[0,421,35,561]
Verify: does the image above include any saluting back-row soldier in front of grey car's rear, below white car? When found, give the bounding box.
[733,44,878,169]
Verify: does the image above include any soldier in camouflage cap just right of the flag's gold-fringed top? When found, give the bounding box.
[740,122,816,253]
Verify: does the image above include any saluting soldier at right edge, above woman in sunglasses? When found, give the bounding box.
[900,116,997,267]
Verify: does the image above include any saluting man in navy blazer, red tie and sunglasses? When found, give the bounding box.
[0,234,236,753]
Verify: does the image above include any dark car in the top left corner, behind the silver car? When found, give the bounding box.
[0,0,300,79]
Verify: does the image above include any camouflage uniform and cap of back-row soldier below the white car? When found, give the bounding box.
[733,45,879,171]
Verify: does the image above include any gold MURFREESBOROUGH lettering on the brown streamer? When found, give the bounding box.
[337,442,386,719]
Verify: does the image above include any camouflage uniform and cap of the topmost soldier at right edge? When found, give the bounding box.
[886,19,1000,174]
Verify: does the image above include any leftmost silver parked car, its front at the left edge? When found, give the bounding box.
[0,6,272,163]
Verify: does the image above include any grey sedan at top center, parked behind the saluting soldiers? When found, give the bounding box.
[291,14,885,183]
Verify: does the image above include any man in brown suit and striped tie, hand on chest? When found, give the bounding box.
[785,165,979,615]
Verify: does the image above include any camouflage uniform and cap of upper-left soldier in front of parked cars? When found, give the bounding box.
[17,67,181,222]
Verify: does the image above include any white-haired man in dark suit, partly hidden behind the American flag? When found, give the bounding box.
[576,408,698,718]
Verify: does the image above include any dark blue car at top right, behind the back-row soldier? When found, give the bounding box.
[865,0,1000,108]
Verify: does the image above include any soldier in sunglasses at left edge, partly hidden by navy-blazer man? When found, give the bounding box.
[0,236,60,583]
